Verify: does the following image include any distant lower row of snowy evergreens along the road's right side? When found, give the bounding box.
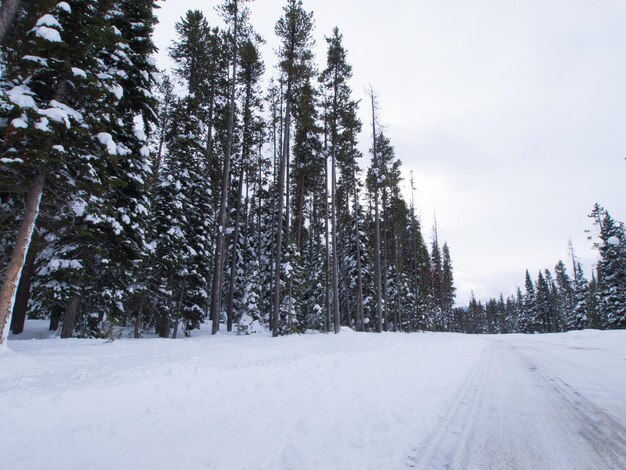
[455,204,626,334]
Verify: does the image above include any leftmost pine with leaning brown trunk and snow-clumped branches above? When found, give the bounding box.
[0,2,92,346]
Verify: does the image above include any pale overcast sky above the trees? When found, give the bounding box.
[156,0,626,305]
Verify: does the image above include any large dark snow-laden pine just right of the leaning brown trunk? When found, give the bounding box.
[7,1,160,337]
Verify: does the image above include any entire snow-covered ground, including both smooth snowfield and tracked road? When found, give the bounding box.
[0,322,626,470]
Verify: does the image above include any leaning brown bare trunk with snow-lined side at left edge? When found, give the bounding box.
[0,174,45,348]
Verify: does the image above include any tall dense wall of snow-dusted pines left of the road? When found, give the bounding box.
[0,0,455,338]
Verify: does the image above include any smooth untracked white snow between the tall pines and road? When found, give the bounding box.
[0,324,485,470]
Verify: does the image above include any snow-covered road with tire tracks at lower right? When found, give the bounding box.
[407,332,626,470]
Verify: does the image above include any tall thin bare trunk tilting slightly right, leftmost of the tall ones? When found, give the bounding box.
[211,2,238,334]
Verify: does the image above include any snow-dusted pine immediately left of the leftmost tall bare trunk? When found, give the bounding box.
[150,11,221,337]
